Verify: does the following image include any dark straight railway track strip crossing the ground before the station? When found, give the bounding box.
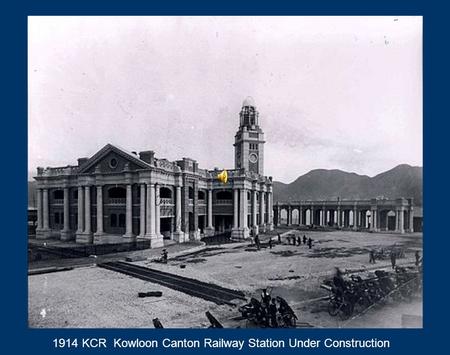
[98,261,246,306]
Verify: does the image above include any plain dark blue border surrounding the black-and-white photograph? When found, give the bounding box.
[0,0,450,354]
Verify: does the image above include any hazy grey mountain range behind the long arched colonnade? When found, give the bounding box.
[273,164,423,206]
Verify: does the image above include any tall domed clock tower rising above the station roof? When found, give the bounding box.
[234,97,265,175]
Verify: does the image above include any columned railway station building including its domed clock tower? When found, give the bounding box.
[35,97,273,247]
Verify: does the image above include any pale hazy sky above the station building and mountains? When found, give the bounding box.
[28,16,423,183]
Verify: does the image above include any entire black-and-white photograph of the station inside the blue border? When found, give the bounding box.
[24,16,424,330]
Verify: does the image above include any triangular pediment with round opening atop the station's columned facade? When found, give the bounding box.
[79,144,150,174]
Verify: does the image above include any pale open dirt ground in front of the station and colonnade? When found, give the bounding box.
[28,231,422,328]
